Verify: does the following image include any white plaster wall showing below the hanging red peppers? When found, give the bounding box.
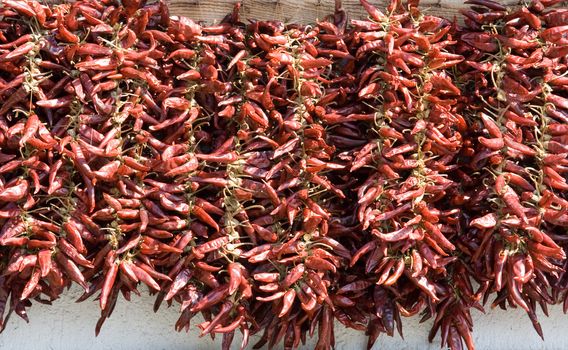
[0,288,568,350]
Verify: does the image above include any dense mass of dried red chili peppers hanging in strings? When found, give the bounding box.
[0,0,568,349]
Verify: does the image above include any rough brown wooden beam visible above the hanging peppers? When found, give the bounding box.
[168,0,519,23]
